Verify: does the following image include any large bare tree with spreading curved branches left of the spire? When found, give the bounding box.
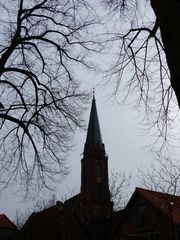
[0,0,98,194]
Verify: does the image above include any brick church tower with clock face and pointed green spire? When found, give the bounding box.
[80,96,113,220]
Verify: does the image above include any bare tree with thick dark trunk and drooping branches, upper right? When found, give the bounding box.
[103,0,180,150]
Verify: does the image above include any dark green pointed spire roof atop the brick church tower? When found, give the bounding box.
[86,96,103,146]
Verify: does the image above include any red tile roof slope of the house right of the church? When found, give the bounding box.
[136,188,180,224]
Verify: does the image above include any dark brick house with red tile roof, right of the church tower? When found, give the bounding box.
[113,188,180,240]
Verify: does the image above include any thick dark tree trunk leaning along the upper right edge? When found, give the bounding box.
[151,0,180,107]
